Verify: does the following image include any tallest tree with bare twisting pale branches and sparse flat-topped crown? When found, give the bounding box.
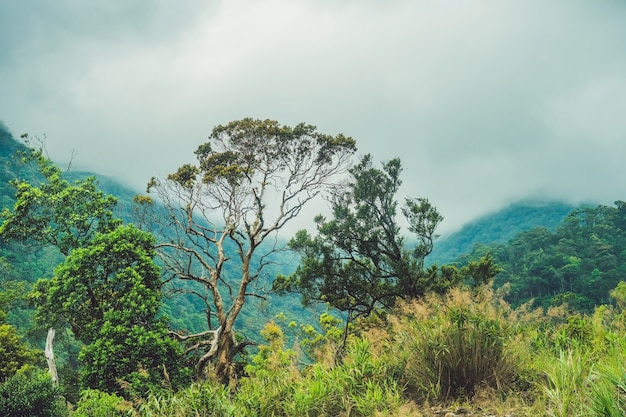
[139,119,356,380]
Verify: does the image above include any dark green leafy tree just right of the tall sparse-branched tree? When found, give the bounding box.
[274,155,460,348]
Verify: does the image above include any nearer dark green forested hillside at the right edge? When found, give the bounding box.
[460,201,626,311]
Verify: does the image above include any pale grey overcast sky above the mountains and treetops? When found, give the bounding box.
[0,0,626,234]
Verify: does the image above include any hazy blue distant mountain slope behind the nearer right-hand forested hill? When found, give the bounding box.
[428,201,576,265]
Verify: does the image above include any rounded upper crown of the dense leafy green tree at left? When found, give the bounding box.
[33,226,161,343]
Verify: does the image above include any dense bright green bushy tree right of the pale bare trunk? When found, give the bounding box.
[35,225,184,395]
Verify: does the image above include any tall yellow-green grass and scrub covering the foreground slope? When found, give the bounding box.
[61,287,626,416]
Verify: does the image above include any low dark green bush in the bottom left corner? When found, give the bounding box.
[0,371,68,417]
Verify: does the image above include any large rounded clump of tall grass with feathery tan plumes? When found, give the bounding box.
[391,288,518,400]
